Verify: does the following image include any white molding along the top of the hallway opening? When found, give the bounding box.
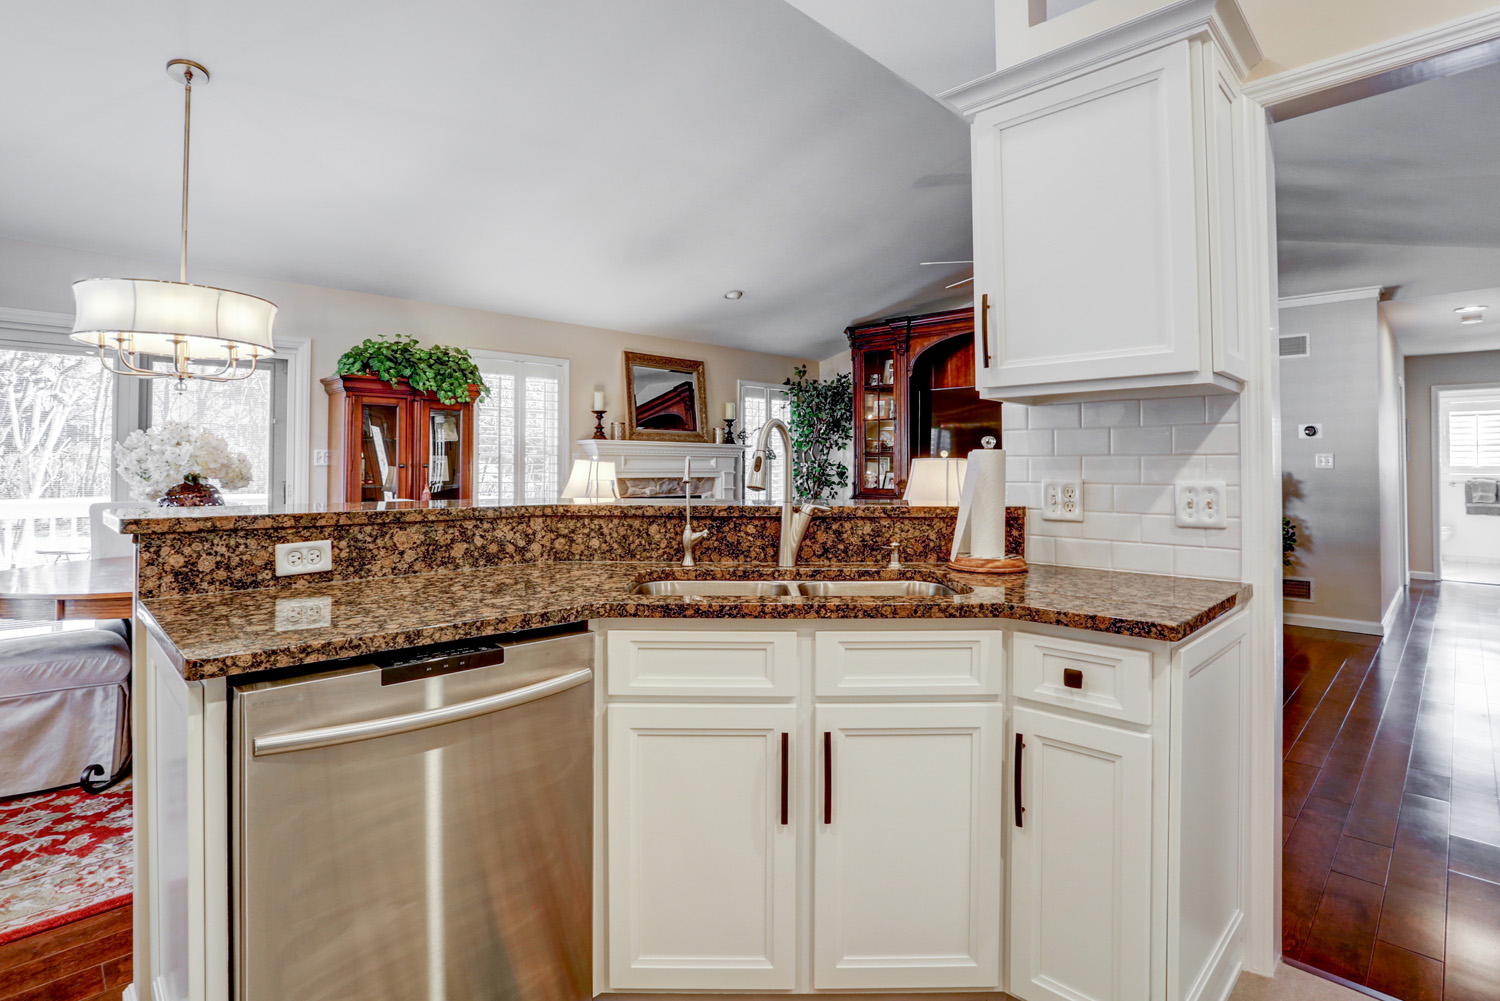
[1244,8,1500,119]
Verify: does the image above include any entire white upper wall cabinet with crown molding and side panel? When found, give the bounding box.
[948,2,1248,402]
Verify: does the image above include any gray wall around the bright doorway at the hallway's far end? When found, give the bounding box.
[1406,351,1500,575]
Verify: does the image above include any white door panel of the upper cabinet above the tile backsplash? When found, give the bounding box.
[974,42,1203,389]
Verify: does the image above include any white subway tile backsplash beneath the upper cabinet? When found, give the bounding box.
[1001,396,1242,579]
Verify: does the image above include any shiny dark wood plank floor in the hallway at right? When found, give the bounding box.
[1281,584,1500,1001]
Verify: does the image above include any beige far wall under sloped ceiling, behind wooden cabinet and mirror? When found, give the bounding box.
[0,240,800,501]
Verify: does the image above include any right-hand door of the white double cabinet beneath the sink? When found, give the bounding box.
[813,704,1002,990]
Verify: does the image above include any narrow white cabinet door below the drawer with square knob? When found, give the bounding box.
[1010,708,1151,1001]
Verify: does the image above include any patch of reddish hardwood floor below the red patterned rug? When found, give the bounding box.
[0,903,131,1001]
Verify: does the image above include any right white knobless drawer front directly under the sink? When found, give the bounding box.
[813,630,1001,696]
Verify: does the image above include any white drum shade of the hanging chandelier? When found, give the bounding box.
[72,278,276,359]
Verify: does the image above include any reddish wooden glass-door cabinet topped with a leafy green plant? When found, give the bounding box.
[323,375,480,504]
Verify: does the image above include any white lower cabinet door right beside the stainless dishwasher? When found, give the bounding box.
[608,705,797,990]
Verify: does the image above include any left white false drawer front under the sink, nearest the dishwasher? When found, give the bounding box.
[608,629,797,696]
